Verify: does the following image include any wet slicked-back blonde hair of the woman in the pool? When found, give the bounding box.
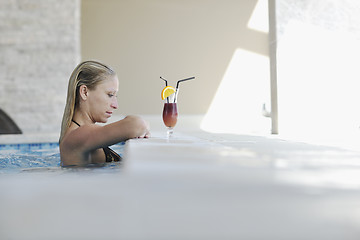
[59,61,116,143]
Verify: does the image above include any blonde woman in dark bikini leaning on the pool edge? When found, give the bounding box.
[59,61,149,166]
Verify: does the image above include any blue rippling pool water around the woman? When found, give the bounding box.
[0,142,125,173]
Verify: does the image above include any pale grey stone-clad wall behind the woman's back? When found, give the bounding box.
[0,0,80,133]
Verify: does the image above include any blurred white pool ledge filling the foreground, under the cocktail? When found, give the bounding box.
[0,115,360,240]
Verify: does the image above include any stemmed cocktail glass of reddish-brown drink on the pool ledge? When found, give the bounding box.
[163,89,178,139]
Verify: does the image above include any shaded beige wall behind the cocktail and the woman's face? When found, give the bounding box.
[81,0,268,117]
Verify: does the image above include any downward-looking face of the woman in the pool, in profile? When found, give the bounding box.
[88,76,119,123]
